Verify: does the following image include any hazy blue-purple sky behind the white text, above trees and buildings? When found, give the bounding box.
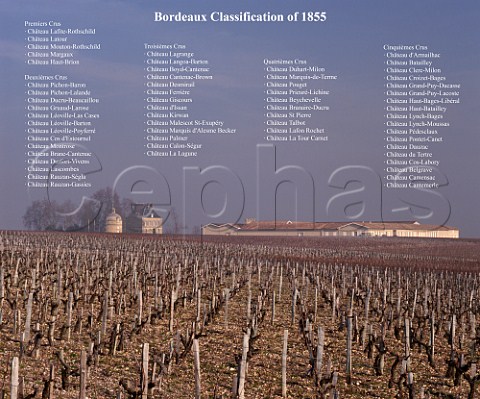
[0,0,480,237]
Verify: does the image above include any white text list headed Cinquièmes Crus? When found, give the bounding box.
[383,44,461,189]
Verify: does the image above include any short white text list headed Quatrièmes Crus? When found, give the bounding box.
[263,58,338,143]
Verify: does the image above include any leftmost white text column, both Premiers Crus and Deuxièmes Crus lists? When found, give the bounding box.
[24,20,101,188]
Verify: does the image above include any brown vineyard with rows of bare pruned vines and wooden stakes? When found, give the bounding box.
[0,232,480,399]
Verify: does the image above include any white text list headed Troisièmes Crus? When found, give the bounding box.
[144,43,237,158]
